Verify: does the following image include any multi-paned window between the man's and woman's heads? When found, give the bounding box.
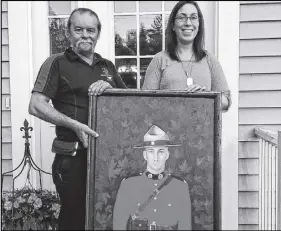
[114,1,177,88]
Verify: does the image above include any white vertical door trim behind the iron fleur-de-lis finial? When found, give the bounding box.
[8,1,36,188]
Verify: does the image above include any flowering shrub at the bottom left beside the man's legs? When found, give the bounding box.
[1,187,60,230]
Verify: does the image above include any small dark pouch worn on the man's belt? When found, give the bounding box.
[52,137,85,156]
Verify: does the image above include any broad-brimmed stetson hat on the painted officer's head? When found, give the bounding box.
[134,125,180,148]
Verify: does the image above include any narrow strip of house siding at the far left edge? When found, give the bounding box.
[1,1,13,190]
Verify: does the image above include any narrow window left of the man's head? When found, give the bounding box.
[48,1,77,55]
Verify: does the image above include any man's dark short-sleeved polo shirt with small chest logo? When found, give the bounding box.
[32,48,126,141]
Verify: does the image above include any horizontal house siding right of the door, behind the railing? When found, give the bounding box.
[238,1,281,230]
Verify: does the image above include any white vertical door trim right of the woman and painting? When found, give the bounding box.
[217,1,239,230]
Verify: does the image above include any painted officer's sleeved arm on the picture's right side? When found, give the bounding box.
[178,183,192,230]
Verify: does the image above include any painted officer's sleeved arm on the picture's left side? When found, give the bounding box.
[113,180,131,230]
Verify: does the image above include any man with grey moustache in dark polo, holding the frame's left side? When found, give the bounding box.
[29,8,126,230]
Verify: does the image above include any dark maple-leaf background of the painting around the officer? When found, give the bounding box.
[89,96,215,230]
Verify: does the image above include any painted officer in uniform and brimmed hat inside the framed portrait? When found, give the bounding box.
[113,125,191,230]
